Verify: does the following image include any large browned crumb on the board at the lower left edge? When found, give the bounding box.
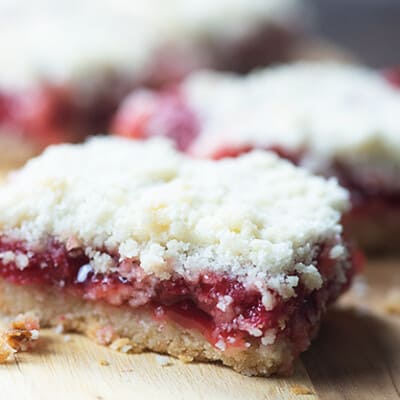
[0,313,40,362]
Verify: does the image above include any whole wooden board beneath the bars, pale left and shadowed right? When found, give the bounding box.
[0,260,400,400]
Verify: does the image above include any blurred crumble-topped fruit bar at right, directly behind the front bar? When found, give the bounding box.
[113,63,400,250]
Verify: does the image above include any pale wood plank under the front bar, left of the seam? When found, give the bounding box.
[0,331,317,400]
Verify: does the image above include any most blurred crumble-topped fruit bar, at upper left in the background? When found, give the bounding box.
[0,0,302,164]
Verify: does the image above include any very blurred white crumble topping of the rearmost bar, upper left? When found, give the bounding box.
[0,0,302,89]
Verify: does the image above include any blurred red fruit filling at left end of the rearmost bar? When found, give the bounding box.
[0,86,122,148]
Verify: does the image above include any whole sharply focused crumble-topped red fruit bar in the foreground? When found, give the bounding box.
[0,137,357,375]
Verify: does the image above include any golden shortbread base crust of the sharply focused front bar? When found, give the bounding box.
[0,279,296,376]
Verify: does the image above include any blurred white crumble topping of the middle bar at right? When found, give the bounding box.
[181,62,400,162]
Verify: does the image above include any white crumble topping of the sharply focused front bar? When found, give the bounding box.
[0,137,348,298]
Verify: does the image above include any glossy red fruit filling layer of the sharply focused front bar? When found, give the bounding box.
[0,238,353,353]
